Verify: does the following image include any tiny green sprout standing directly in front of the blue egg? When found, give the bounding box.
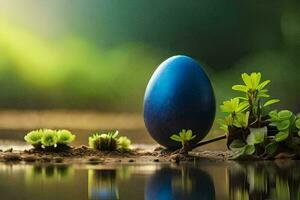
[170,129,196,153]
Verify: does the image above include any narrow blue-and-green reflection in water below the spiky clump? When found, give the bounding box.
[88,169,119,200]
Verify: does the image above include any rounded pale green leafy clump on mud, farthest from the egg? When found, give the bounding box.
[24,129,75,150]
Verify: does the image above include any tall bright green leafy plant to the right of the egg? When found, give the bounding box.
[219,73,300,159]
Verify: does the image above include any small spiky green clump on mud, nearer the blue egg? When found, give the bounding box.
[89,131,131,151]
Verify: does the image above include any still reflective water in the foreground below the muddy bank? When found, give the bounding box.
[0,161,300,200]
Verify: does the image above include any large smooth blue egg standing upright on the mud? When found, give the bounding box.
[144,55,216,149]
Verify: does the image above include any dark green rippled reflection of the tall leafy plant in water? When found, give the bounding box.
[229,161,300,200]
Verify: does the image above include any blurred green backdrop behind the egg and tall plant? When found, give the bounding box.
[0,0,300,112]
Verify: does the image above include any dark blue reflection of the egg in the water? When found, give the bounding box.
[145,167,215,200]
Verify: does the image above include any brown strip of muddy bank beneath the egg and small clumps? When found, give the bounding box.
[0,146,229,164]
